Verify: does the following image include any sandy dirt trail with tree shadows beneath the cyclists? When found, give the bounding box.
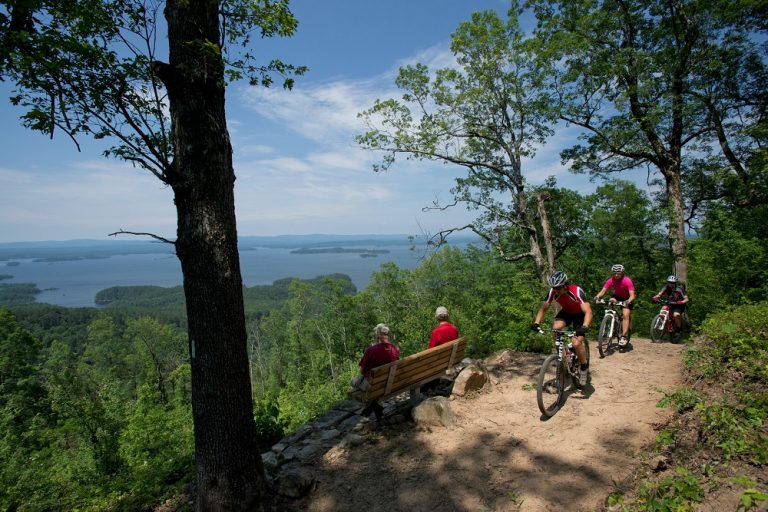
[292,338,683,512]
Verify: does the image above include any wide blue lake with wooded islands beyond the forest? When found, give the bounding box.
[0,244,421,307]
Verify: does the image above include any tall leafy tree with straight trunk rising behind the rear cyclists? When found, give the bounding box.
[533,0,764,281]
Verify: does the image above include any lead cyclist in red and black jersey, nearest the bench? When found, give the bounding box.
[531,272,592,386]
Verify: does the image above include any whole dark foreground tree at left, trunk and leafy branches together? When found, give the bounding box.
[0,0,304,511]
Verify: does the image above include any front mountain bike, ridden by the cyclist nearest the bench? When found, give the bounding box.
[536,329,589,417]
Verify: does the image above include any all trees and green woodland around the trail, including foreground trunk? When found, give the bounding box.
[0,0,768,510]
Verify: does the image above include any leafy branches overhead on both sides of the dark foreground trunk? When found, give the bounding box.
[0,0,307,183]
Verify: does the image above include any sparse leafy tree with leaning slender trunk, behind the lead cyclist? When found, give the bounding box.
[357,2,553,279]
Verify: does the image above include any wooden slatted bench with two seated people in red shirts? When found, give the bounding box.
[349,337,467,403]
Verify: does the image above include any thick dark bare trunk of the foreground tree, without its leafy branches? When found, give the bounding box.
[158,0,265,512]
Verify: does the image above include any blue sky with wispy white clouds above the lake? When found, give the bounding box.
[0,0,612,242]
